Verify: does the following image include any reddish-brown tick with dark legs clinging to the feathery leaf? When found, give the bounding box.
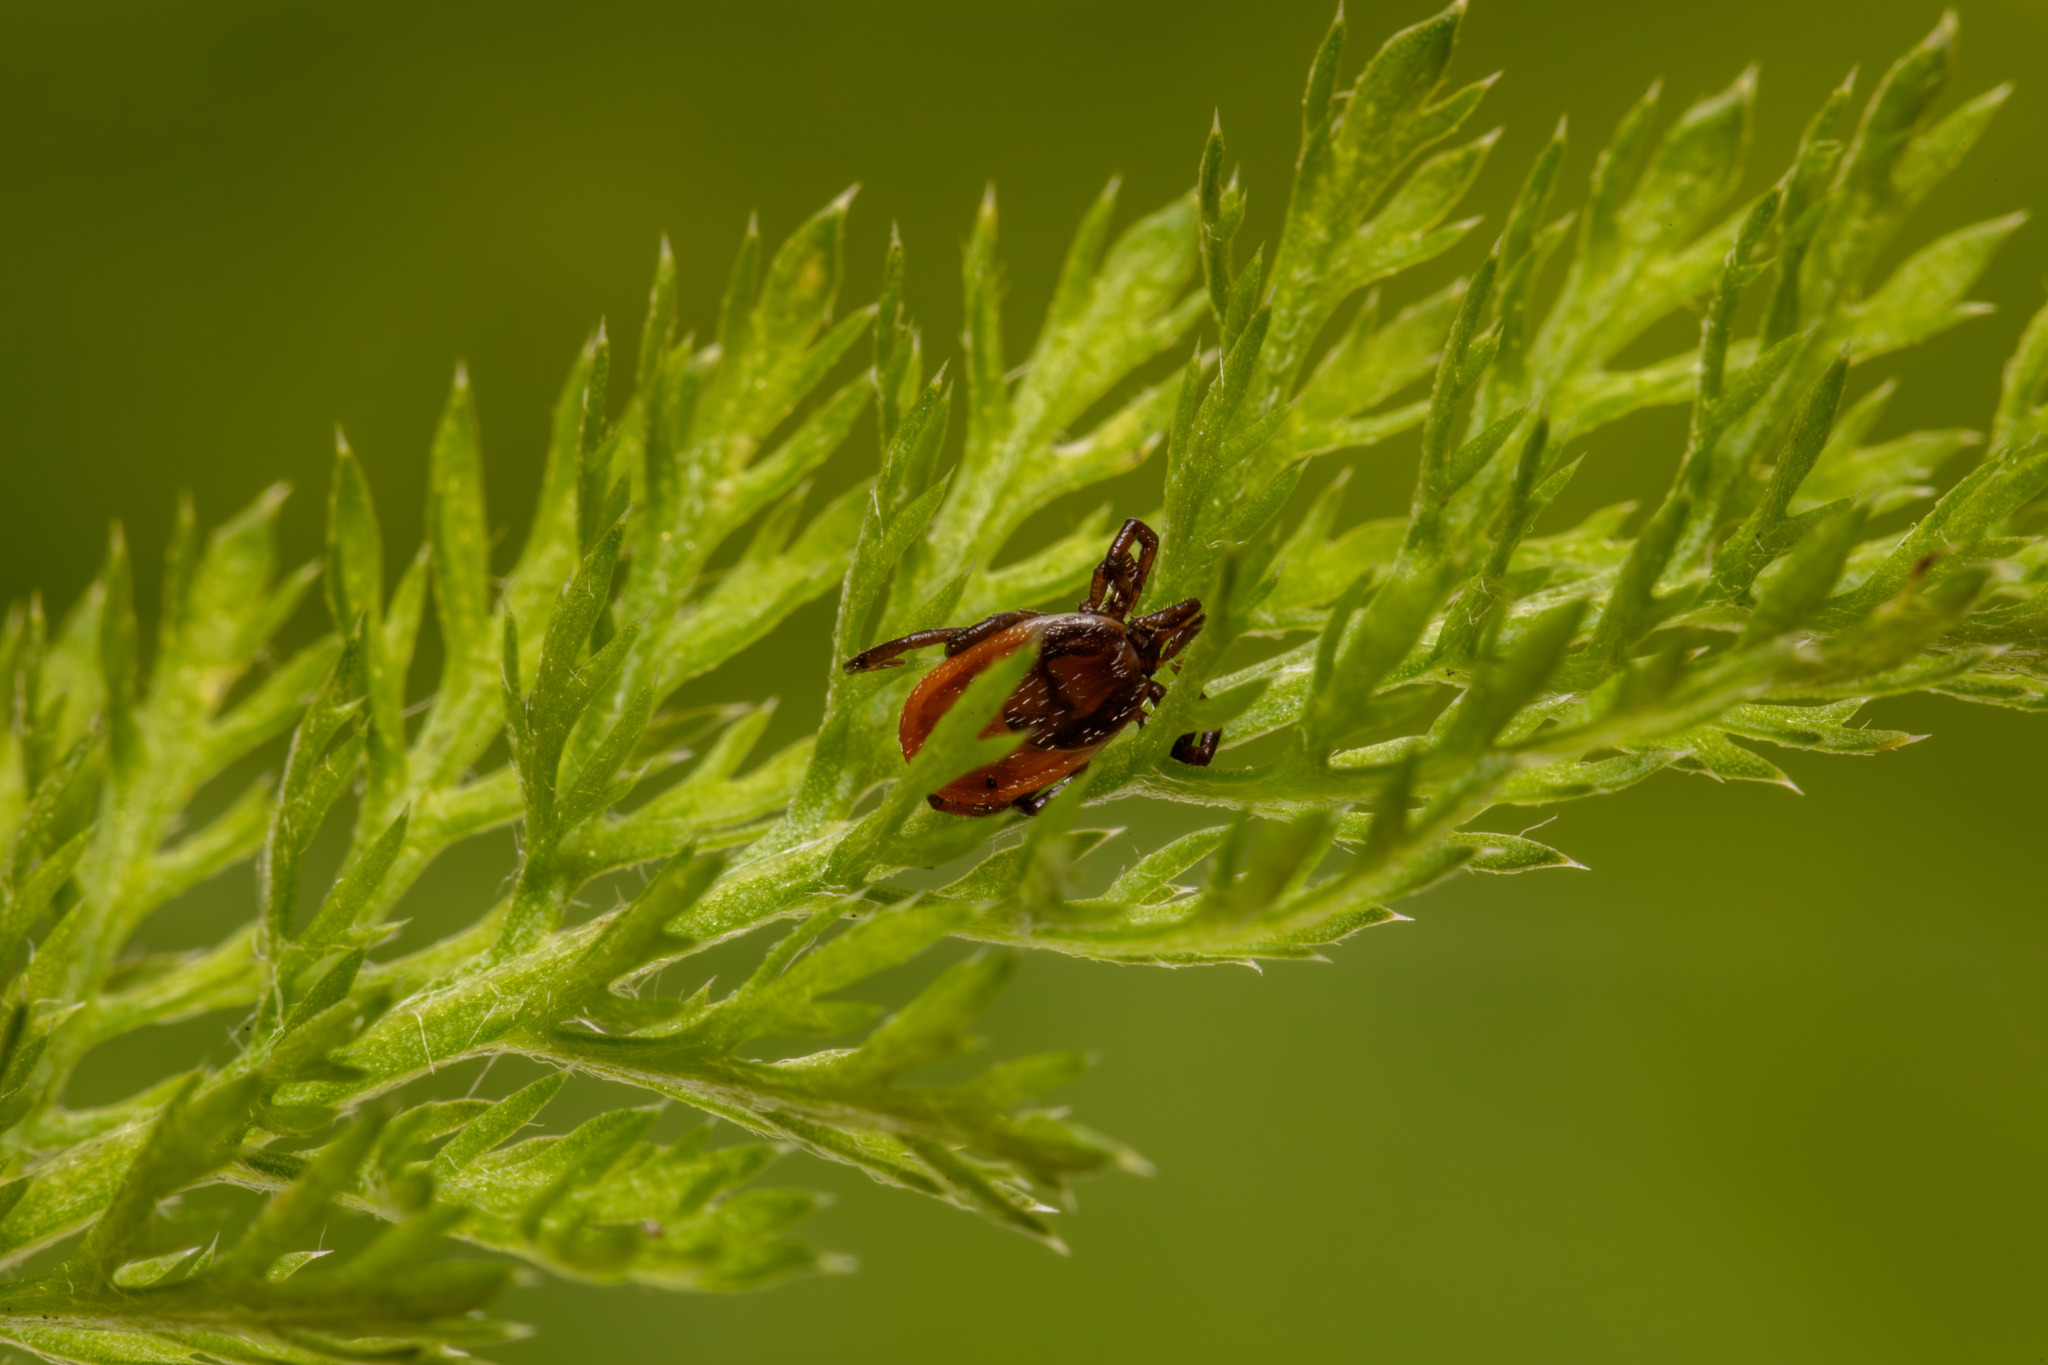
[844,518,1223,814]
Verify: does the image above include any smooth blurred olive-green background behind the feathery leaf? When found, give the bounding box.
[0,0,2048,1365]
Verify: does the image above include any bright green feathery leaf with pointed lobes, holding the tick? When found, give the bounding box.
[0,8,2048,1363]
